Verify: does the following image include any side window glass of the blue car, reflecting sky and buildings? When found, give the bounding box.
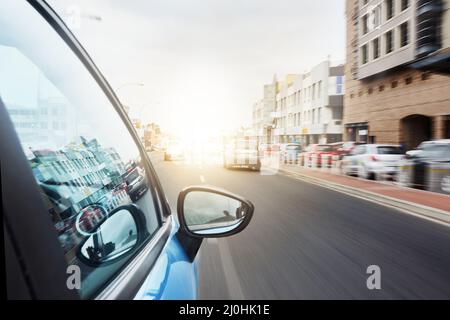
[0,1,160,298]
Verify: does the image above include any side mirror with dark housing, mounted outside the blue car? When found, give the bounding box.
[178,186,254,238]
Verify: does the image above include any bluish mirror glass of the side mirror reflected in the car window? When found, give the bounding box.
[80,210,137,264]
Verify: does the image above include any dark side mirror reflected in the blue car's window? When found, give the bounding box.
[76,205,147,267]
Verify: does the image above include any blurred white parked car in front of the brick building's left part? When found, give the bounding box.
[342,144,404,179]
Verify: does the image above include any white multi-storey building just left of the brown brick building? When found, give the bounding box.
[273,61,344,146]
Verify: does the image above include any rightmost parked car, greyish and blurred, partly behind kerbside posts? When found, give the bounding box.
[400,139,450,189]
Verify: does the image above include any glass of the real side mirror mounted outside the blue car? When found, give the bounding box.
[183,191,248,235]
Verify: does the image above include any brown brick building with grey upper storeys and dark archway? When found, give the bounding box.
[344,0,450,149]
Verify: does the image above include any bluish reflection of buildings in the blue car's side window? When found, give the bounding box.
[29,137,131,258]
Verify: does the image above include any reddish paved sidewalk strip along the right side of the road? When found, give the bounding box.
[280,165,450,221]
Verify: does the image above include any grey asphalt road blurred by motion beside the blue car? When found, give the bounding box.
[156,162,450,299]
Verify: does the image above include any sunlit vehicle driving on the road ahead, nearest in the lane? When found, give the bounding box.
[223,137,261,171]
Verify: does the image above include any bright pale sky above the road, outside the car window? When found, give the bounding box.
[49,0,345,134]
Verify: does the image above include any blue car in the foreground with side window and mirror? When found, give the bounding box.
[0,0,254,300]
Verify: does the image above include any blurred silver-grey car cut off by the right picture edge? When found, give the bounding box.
[399,139,450,190]
